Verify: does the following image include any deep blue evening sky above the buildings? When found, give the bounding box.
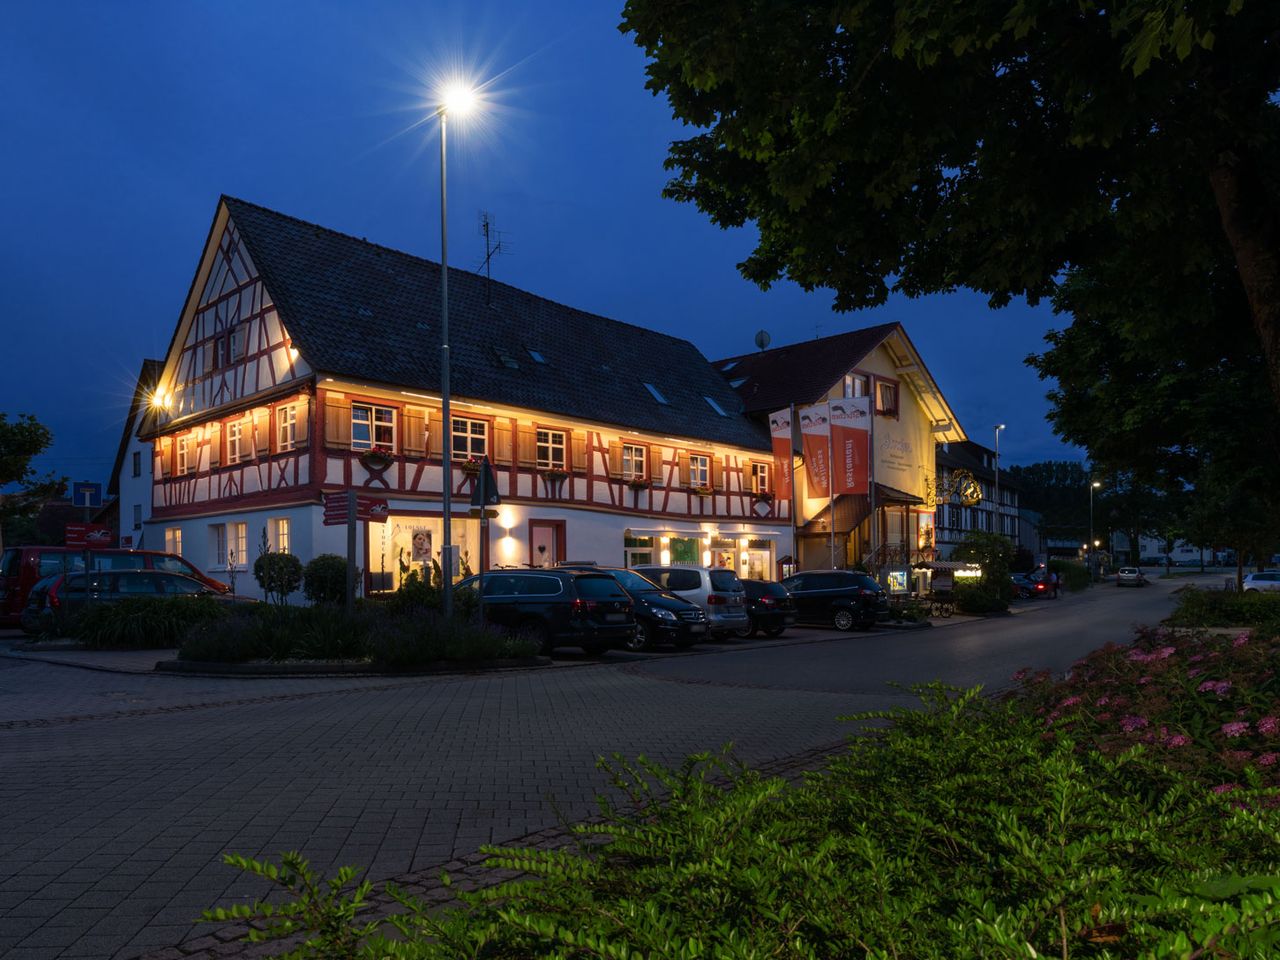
[0,0,1080,481]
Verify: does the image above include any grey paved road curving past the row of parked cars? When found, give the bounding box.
[0,581,1185,960]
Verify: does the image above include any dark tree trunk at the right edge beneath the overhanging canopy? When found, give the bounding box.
[1208,148,1280,408]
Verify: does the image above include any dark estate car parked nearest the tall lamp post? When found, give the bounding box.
[454,570,636,654]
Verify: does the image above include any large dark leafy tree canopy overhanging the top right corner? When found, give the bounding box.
[622,0,1280,403]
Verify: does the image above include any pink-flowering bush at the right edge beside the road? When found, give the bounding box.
[1014,627,1280,791]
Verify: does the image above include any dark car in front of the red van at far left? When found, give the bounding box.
[31,570,257,635]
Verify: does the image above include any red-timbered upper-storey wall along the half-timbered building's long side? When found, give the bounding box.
[312,385,790,522]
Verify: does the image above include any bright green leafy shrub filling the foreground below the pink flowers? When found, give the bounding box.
[206,687,1280,960]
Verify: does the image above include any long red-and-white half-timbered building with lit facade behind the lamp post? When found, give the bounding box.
[141,197,791,593]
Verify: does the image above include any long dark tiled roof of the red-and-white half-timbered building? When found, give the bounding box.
[223,197,768,449]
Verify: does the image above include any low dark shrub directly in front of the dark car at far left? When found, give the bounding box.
[69,596,227,650]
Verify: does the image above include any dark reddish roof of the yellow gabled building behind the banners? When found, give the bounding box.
[712,323,899,412]
